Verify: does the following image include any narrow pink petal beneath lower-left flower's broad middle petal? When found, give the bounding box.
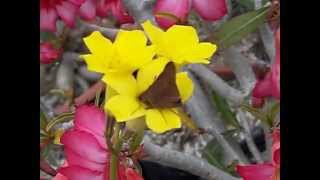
[64,148,106,172]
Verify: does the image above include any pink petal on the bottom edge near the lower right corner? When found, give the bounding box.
[237,164,275,180]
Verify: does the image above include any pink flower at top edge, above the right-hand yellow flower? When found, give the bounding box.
[154,0,227,29]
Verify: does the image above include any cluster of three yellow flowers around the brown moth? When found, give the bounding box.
[82,21,217,133]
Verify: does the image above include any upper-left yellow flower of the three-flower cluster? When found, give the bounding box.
[82,30,155,96]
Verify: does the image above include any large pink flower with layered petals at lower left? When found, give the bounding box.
[58,105,140,180]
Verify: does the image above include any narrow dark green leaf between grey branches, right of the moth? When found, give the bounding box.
[212,92,240,129]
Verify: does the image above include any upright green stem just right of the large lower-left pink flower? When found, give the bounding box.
[110,123,122,180]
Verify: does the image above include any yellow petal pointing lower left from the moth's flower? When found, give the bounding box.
[105,95,146,122]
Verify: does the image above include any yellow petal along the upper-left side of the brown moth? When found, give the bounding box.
[137,58,169,94]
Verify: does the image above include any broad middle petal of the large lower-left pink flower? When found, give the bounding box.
[61,130,108,163]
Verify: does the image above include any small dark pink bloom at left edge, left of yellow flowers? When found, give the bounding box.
[40,42,61,64]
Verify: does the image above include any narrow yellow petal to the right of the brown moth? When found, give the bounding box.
[176,72,193,103]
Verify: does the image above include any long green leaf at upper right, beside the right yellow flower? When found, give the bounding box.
[213,7,269,48]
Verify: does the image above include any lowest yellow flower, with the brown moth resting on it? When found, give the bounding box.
[106,57,193,133]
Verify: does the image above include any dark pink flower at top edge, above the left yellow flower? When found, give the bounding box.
[97,0,133,24]
